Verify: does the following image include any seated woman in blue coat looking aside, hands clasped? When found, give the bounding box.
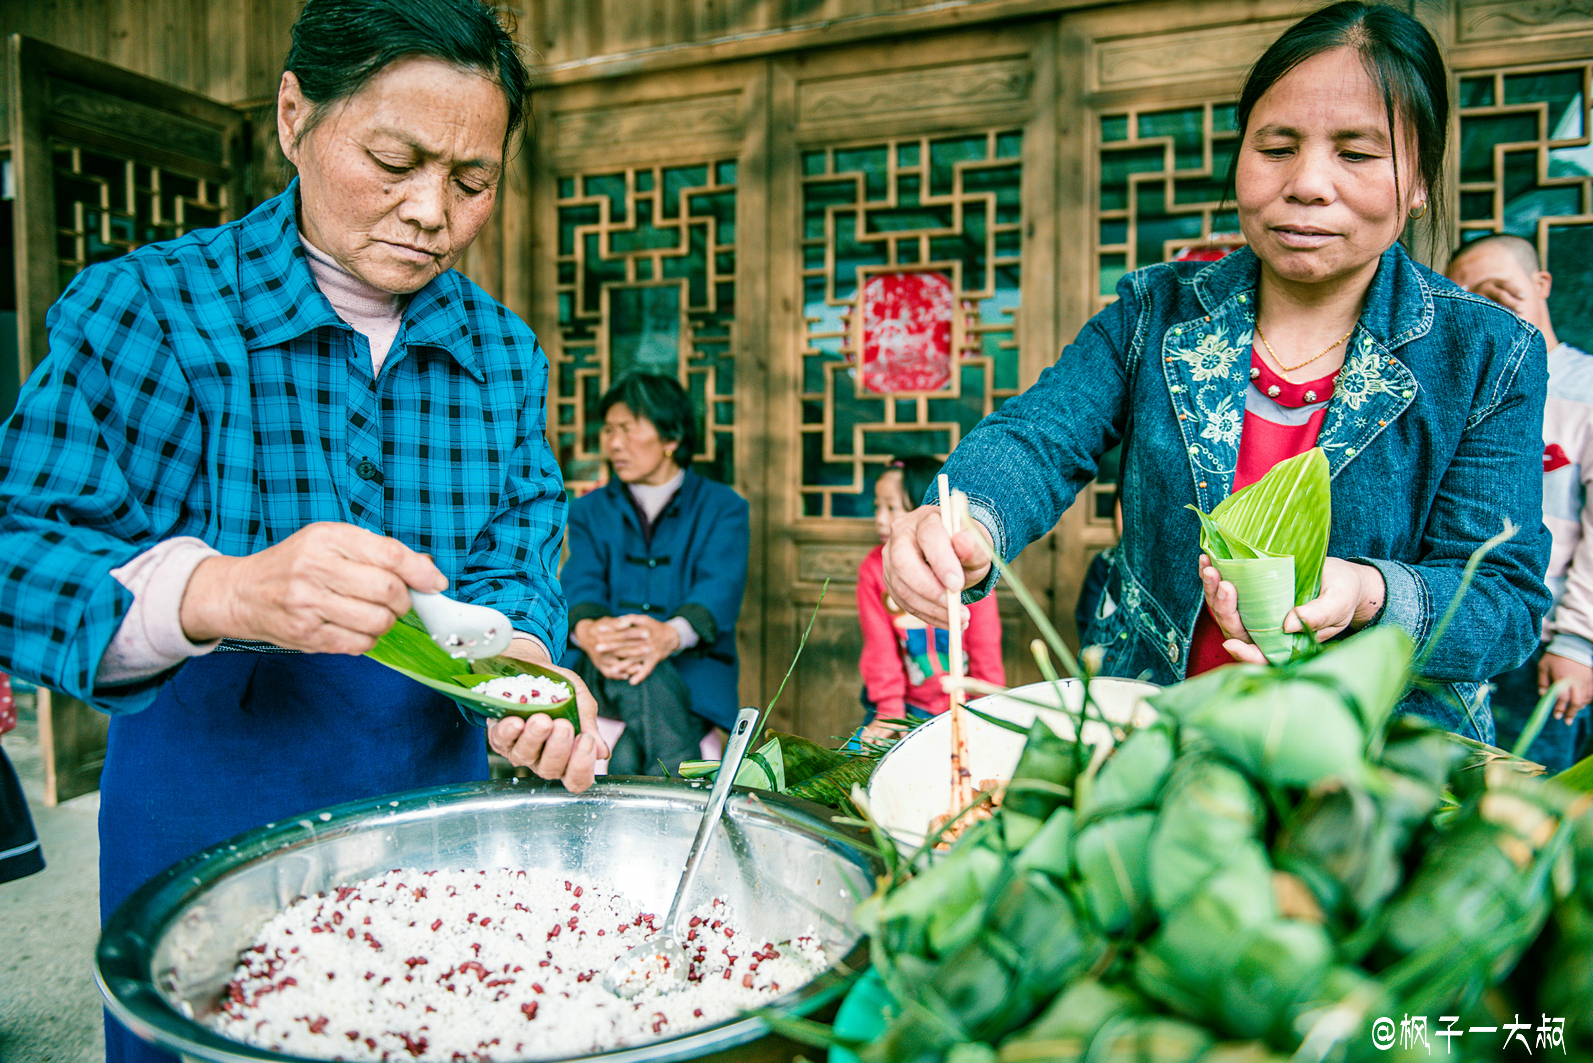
[561,373,747,775]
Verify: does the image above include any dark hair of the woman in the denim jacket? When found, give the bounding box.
[1228,0,1450,245]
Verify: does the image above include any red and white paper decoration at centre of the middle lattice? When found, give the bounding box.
[863,273,956,394]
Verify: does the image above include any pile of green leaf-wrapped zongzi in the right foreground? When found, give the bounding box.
[776,507,1593,1063]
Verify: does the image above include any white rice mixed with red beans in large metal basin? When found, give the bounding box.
[210,870,828,1063]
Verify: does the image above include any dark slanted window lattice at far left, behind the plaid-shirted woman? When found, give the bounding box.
[54,142,228,294]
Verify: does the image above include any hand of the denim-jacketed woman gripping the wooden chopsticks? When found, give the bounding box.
[884,505,991,630]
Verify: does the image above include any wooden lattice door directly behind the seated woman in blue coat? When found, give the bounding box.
[525,64,769,723]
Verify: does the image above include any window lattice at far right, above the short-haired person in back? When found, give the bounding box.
[1458,62,1593,347]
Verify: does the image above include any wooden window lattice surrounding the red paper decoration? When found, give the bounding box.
[798,129,1023,518]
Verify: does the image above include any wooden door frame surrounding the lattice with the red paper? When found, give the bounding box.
[763,18,1070,738]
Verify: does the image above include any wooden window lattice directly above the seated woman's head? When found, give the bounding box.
[553,159,736,494]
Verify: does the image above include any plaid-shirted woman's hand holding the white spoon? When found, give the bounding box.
[180,521,448,655]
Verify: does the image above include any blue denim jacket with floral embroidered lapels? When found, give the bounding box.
[927,245,1550,741]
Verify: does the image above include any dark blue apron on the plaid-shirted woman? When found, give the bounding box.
[99,652,487,1063]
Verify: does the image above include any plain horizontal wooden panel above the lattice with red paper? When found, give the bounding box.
[797,59,1034,124]
